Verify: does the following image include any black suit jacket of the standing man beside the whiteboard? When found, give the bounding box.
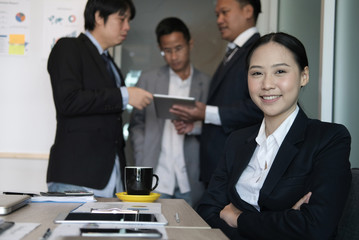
[47,34,125,189]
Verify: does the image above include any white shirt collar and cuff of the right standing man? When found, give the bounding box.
[204,27,258,126]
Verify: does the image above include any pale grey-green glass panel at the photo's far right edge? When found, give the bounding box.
[333,0,359,167]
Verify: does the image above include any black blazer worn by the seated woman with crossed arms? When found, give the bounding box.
[198,110,351,240]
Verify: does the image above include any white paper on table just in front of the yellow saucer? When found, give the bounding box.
[72,202,162,214]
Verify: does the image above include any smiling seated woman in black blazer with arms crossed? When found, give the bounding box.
[198,33,351,240]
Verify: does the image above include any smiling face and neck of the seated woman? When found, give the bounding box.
[248,42,309,136]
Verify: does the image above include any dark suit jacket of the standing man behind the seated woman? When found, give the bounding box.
[200,34,263,182]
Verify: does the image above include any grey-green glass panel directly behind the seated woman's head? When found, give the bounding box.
[278,0,321,118]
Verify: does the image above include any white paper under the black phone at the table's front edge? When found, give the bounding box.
[48,223,168,240]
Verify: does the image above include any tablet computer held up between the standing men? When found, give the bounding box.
[153,94,196,119]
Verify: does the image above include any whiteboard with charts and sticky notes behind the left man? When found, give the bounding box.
[0,0,86,154]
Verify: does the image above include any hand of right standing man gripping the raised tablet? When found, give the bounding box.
[170,101,206,122]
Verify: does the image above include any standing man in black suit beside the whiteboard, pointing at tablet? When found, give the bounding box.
[47,0,152,197]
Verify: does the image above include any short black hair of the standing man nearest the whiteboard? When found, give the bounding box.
[84,0,136,31]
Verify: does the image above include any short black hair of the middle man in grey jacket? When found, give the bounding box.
[156,17,191,45]
